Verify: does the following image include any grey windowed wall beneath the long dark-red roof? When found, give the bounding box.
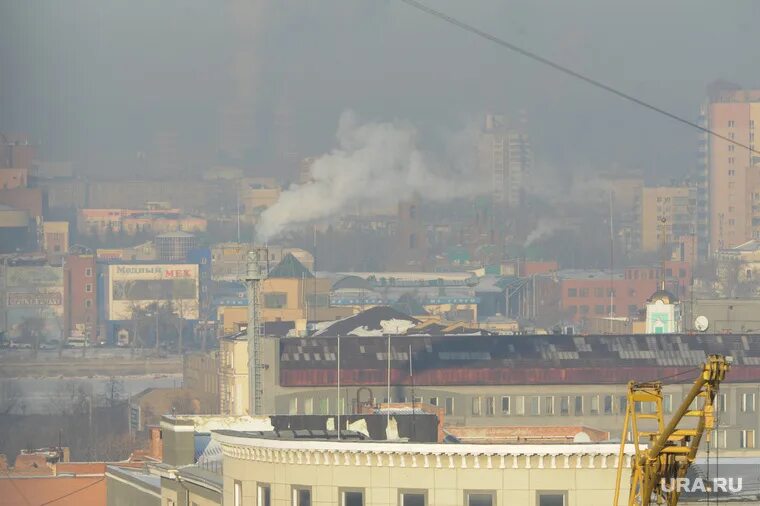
[264,380,760,450]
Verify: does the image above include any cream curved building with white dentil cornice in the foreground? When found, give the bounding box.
[212,430,633,506]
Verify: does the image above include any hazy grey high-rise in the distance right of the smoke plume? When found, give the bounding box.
[478,114,533,207]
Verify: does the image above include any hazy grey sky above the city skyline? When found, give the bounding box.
[0,0,760,177]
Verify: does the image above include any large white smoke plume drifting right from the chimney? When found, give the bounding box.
[256,111,481,242]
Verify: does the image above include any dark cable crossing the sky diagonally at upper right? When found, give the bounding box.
[399,0,760,154]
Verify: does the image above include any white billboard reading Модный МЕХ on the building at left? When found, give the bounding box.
[107,264,199,320]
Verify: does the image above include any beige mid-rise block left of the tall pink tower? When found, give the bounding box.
[638,186,697,251]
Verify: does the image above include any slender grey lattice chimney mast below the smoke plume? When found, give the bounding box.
[245,248,267,415]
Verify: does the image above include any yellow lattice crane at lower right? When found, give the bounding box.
[614,355,732,506]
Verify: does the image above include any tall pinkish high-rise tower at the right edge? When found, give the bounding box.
[697,84,760,251]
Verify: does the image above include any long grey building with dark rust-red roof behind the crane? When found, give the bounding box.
[248,334,760,452]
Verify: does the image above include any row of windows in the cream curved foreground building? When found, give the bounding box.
[233,481,567,506]
